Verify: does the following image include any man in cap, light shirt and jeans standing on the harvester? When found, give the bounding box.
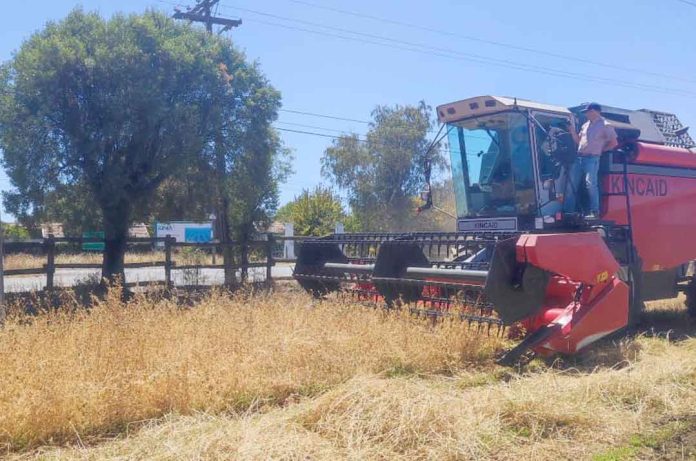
[563,102,618,219]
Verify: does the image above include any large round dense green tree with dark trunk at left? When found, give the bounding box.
[0,10,280,278]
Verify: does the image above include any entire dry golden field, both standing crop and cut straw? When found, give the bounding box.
[0,293,696,460]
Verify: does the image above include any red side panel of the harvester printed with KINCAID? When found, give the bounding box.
[602,174,696,271]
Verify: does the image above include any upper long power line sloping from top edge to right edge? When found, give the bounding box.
[287,0,696,82]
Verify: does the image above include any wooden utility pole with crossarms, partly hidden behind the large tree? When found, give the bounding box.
[173,0,244,287]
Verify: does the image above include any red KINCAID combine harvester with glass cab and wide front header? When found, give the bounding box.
[294,96,696,363]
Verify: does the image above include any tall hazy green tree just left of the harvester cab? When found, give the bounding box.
[322,102,443,231]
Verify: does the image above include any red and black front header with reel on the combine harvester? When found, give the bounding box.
[294,232,628,363]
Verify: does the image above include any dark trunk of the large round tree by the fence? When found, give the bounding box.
[102,203,130,283]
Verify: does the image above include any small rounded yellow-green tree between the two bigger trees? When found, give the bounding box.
[276,186,348,235]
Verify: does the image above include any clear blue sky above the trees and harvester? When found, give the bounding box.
[0,0,696,219]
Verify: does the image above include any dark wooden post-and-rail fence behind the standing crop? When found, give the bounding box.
[3,234,302,290]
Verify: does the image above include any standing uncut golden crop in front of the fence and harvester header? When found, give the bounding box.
[0,293,501,451]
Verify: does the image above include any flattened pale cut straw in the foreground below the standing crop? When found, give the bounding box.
[17,338,696,461]
